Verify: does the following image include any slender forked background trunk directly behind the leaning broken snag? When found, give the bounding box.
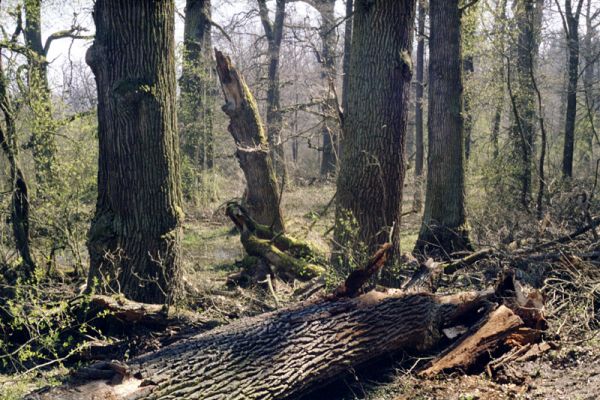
[257,0,287,184]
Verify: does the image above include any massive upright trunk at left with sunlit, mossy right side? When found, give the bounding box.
[86,0,183,303]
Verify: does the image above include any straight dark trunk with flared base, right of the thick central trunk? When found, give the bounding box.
[415,0,471,257]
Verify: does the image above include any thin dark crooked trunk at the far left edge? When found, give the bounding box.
[0,54,35,279]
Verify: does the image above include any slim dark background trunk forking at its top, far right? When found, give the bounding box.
[561,0,583,178]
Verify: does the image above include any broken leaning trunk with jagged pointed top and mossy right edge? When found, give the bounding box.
[215,50,284,232]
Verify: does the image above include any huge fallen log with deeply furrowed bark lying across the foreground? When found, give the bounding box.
[24,272,544,400]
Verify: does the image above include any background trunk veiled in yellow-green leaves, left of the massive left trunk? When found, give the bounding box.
[24,0,56,191]
